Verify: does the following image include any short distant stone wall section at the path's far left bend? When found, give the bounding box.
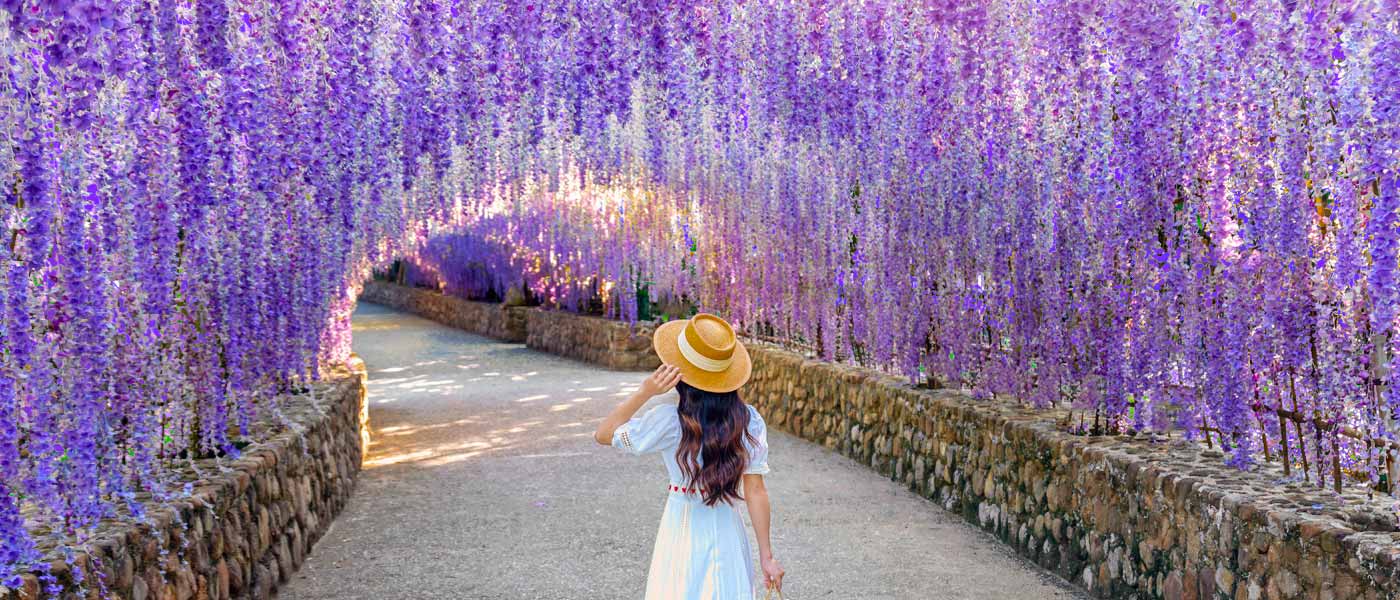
[360,280,531,343]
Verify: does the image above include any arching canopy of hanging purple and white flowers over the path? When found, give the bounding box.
[0,0,1400,583]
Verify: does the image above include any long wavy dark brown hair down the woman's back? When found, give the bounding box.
[676,382,749,506]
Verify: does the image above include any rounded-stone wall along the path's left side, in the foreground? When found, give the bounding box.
[0,361,368,600]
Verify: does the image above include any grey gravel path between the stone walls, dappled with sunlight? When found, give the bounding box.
[280,303,1086,600]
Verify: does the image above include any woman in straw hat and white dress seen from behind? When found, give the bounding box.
[594,315,783,600]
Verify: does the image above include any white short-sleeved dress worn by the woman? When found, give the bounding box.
[612,404,769,600]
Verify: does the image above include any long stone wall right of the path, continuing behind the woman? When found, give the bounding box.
[352,281,1400,600]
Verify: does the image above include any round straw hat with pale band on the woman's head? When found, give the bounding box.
[651,313,753,392]
